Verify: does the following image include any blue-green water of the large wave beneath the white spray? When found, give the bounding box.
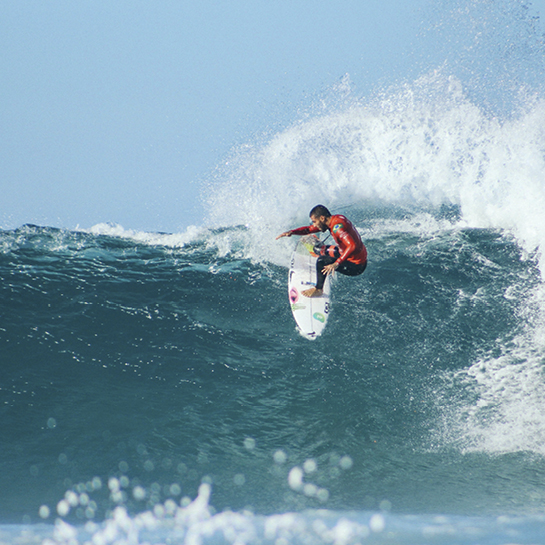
[0,210,545,543]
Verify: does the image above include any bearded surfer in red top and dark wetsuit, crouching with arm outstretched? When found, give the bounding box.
[276,204,367,297]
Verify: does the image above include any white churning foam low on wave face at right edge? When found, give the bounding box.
[437,285,545,456]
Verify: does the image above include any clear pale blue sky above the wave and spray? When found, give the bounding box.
[0,0,545,232]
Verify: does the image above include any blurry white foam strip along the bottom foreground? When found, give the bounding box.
[21,484,543,545]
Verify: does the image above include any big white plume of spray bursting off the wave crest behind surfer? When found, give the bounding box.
[209,71,545,266]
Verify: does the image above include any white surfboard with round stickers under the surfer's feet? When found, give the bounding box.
[288,235,331,340]
